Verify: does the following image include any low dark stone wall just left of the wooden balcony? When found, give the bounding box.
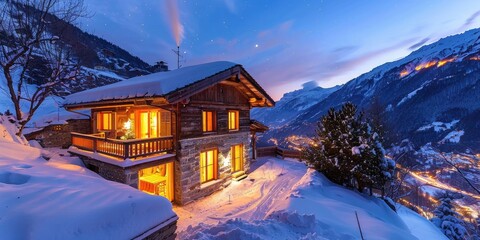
[25,119,92,148]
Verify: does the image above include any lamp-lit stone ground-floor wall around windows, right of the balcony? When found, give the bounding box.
[175,132,252,205]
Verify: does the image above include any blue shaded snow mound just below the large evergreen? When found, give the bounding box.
[272,169,418,239]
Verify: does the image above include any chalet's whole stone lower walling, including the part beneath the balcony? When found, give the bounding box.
[74,132,252,205]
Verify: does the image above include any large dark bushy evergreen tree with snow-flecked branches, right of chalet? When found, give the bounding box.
[304,103,394,191]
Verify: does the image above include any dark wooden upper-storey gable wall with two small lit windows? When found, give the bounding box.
[180,84,250,139]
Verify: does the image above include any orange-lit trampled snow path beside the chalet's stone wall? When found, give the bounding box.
[174,158,307,231]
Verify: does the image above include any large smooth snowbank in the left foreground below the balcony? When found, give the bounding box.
[0,124,176,239]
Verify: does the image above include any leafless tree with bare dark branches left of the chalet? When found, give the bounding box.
[0,0,85,135]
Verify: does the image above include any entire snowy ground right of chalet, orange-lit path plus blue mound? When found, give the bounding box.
[174,158,446,239]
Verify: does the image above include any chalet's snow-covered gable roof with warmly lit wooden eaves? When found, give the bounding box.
[64,62,275,109]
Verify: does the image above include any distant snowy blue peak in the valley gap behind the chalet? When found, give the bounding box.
[251,82,341,128]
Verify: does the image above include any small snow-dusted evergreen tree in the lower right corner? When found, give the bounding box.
[431,191,467,240]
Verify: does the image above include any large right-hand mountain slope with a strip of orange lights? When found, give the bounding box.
[262,29,480,149]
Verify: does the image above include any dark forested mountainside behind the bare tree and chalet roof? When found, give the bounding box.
[0,3,154,96]
